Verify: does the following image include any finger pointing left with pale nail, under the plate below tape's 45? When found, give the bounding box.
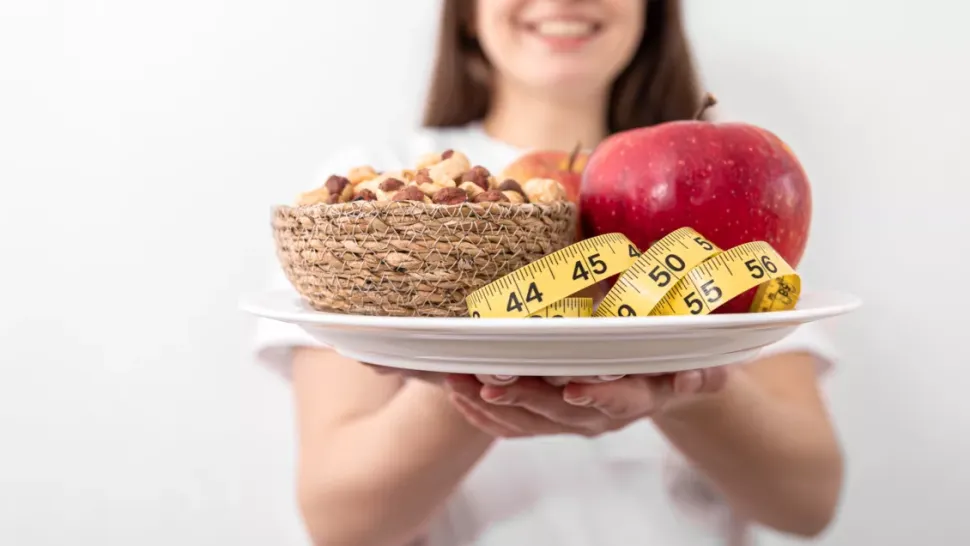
[563,375,669,419]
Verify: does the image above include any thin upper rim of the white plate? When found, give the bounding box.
[238,289,863,334]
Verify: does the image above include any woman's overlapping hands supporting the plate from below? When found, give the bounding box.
[438,368,728,438]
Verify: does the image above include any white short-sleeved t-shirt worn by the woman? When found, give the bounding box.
[255,124,834,546]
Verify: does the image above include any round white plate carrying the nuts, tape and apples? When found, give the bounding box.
[241,291,861,376]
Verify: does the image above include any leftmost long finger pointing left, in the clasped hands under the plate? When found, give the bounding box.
[481,378,606,431]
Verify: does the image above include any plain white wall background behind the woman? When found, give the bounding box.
[0,0,970,546]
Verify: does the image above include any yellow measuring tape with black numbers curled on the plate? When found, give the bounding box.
[465,227,801,318]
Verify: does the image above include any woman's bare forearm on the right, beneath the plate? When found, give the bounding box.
[654,353,842,536]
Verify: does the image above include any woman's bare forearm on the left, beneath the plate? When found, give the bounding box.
[293,349,492,546]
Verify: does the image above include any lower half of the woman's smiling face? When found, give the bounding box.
[475,0,646,95]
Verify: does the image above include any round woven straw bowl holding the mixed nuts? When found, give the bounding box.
[272,201,576,317]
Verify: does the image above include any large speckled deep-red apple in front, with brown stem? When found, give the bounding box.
[580,96,812,313]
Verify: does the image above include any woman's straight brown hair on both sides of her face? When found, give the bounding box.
[424,0,701,133]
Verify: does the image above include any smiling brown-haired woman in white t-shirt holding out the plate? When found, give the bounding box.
[259,0,842,546]
